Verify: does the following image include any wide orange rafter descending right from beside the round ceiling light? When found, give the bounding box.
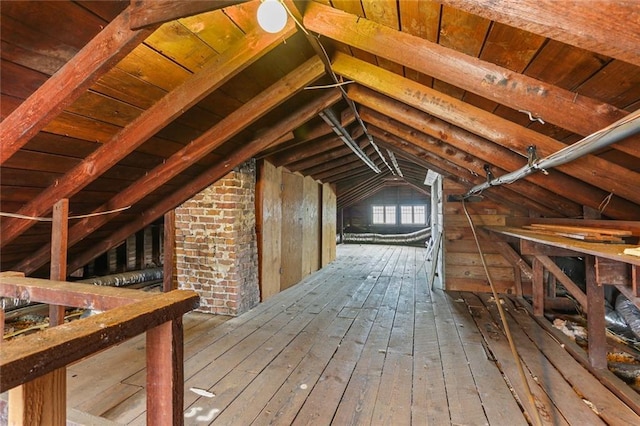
[304,3,627,136]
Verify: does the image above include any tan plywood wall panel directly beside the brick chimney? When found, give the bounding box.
[256,161,282,301]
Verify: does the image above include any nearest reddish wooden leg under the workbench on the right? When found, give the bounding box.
[584,256,607,369]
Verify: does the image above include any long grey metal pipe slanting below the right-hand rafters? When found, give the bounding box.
[460,110,640,199]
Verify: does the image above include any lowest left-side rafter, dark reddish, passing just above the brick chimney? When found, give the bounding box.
[68,91,341,271]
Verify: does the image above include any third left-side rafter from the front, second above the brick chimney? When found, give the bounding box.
[16,57,324,274]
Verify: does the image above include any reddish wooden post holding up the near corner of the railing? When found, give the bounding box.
[147,318,184,426]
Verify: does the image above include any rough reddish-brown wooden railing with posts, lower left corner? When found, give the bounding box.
[0,272,199,426]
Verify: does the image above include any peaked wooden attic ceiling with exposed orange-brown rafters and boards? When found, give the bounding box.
[0,0,640,273]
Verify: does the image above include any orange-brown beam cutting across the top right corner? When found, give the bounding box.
[441,0,640,66]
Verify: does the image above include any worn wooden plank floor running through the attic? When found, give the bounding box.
[63,245,640,425]
